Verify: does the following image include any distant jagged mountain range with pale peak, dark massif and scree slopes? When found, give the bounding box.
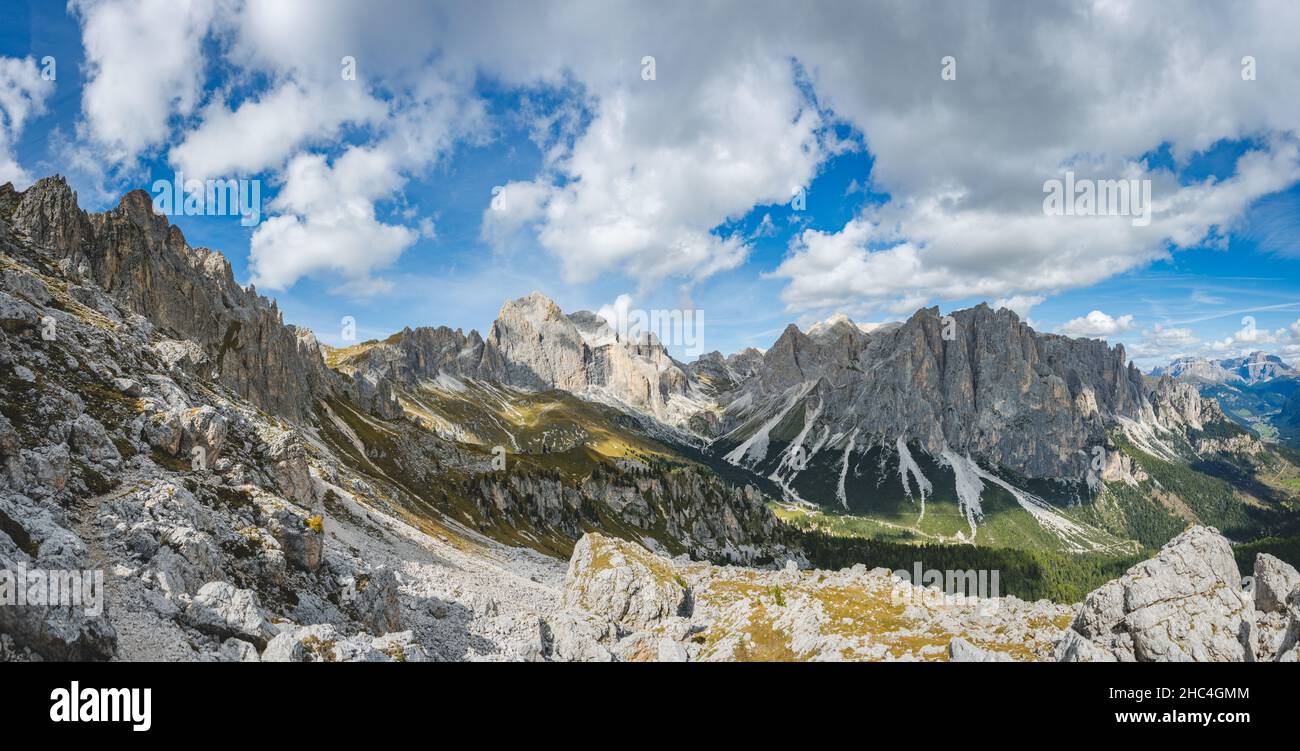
[328,292,1300,551]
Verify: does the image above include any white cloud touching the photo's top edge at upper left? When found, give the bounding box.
[72,0,218,162]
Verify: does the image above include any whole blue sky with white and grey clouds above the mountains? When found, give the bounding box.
[0,0,1300,368]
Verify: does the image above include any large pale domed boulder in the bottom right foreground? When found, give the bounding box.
[1058,526,1256,663]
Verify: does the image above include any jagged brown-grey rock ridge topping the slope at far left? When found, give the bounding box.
[12,177,338,421]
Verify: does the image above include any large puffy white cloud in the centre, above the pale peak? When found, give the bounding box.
[484,60,824,282]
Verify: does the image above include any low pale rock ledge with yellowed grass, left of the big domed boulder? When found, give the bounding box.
[564,534,1073,661]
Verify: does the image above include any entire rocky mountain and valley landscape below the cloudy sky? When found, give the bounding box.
[0,177,1300,661]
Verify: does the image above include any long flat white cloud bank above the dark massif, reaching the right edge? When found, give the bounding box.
[774,138,1300,311]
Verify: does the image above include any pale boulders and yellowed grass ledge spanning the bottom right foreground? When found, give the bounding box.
[550,528,1300,661]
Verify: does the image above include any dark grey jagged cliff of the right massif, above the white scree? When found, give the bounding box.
[719,304,1221,478]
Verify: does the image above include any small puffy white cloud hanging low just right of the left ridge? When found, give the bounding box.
[250,148,419,296]
